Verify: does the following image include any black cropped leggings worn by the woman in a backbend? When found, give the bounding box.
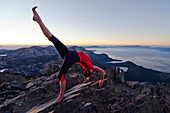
[49,35,80,81]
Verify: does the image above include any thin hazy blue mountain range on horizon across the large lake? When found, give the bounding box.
[83,45,170,52]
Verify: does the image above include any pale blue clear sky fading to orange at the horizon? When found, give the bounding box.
[0,0,170,45]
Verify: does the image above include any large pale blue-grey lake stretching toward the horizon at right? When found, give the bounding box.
[86,47,170,72]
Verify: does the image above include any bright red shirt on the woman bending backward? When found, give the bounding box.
[76,51,94,70]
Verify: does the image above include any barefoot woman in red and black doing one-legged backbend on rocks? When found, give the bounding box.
[32,6,104,103]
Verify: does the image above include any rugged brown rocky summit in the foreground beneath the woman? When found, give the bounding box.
[0,64,170,113]
